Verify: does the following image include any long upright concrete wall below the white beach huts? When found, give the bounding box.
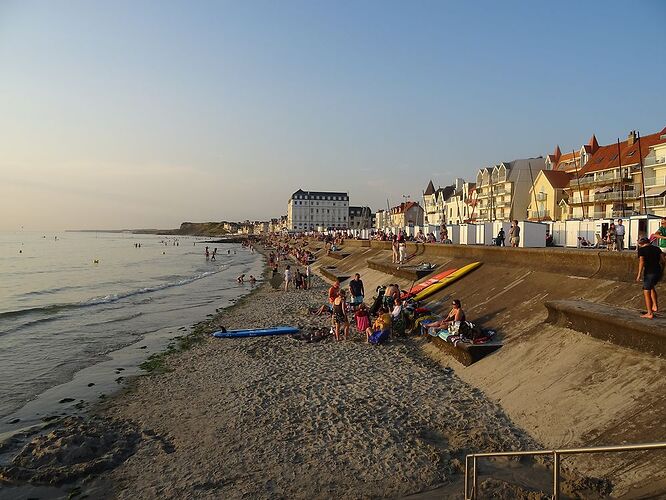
[345,240,666,283]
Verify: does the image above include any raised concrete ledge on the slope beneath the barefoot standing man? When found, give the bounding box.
[545,300,666,356]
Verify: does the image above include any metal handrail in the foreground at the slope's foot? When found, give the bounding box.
[465,443,666,500]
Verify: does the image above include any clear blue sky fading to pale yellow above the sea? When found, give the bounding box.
[0,0,666,230]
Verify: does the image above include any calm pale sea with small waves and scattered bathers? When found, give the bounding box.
[0,231,263,435]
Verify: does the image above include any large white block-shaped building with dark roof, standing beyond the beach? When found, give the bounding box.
[287,189,349,231]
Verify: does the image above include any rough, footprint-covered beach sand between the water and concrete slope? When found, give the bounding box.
[85,272,535,498]
